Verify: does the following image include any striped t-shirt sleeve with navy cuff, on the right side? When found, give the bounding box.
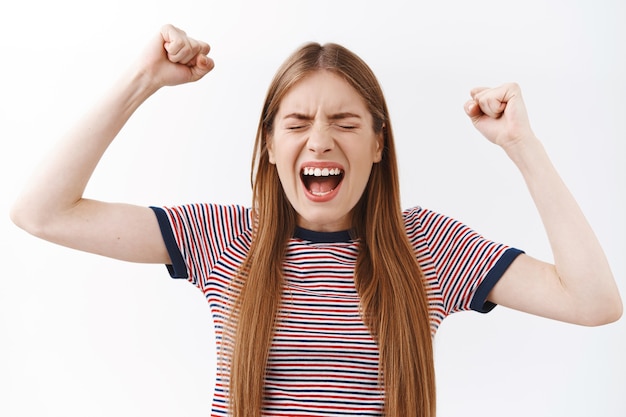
[404,207,523,318]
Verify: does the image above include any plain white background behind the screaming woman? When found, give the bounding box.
[0,0,626,417]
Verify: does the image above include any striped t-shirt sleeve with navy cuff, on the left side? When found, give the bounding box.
[150,204,251,288]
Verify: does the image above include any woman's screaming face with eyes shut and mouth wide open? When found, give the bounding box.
[268,70,383,232]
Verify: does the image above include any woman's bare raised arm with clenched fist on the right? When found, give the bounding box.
[465,84,623,326]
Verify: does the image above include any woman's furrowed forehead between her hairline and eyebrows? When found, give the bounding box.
[278,70,369,117]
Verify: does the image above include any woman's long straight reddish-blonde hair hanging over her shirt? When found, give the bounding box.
[227,43,435,417]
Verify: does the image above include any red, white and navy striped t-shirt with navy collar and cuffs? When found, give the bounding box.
[153,204,521,416]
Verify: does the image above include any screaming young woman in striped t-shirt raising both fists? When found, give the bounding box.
[12,25,622,416]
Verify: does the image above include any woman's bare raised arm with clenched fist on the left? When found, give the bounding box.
[11,25,213,263]
